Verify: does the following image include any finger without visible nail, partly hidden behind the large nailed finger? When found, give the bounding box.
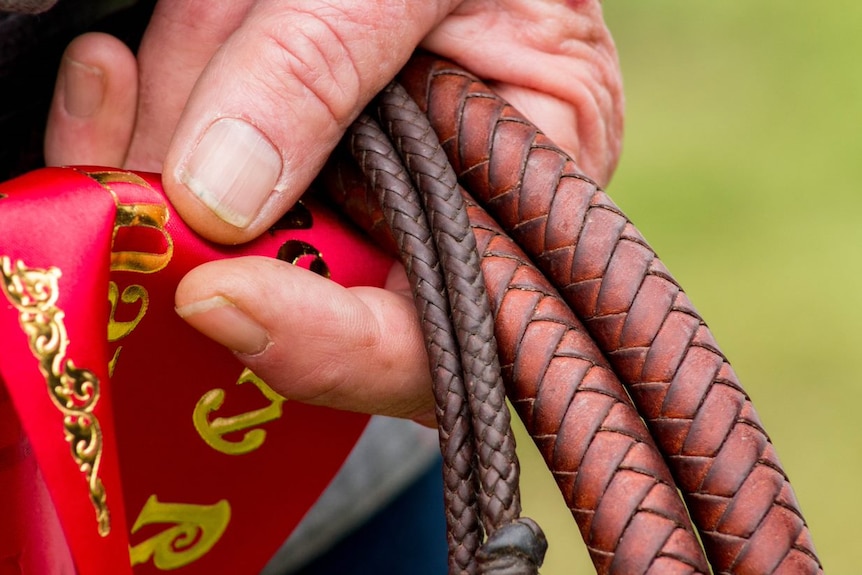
[126,0,253,172]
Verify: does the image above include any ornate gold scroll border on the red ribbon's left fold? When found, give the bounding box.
[0,256,111,537]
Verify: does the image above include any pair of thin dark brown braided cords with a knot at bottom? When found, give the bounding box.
[349,85,547,575]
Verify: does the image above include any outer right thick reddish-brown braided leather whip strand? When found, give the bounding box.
[402,56,822,574]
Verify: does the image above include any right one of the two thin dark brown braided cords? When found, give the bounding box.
[378,85,521,533]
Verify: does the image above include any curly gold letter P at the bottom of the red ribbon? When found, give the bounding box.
[129,495,230,571]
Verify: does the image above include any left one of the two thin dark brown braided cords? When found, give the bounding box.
[348,115,482,575]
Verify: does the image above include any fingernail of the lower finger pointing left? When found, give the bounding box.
[176,296,270,355]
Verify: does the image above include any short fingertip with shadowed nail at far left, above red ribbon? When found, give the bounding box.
[45,33,138,166]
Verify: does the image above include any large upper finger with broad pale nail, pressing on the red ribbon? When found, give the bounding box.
[163,0,457,243]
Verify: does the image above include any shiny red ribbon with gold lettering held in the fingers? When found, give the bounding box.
[0,168,391,575]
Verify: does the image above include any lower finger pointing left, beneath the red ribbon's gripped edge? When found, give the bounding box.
[176,257,434,425]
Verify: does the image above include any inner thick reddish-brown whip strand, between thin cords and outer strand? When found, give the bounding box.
[469,196,709,574]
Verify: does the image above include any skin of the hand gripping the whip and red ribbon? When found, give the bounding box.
[45,0,623,425]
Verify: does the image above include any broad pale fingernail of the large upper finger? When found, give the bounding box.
[177,118,282,228]
